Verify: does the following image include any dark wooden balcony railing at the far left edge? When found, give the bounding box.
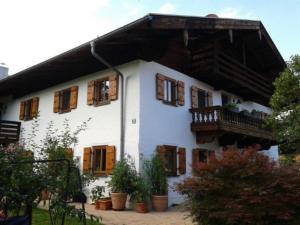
[0,120,21,145]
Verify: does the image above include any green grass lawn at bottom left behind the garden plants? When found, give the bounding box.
[32,209,99,225]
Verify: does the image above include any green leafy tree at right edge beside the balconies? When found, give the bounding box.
[267,55,300,153]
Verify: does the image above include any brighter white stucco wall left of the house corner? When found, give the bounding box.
[2,60,140,199]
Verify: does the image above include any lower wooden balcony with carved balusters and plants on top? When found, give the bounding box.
[190,106,273,142]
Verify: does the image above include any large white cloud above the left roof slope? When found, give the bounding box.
[0,0,116,74]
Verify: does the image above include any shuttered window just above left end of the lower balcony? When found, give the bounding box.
[191,86,213,108]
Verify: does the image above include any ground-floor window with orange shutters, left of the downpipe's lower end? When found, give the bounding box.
[83,145,116,176]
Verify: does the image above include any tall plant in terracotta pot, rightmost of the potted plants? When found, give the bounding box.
[144,155,168,212]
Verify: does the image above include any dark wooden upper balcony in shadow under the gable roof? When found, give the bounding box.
[191,45,273,104]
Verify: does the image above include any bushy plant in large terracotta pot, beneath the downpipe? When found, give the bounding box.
[108,158,136,210]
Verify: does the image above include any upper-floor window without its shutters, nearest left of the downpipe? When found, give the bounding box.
[95,77,109,105]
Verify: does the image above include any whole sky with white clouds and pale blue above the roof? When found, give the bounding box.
[0,0,300,75]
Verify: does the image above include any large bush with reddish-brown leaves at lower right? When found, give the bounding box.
[177,150,300,225]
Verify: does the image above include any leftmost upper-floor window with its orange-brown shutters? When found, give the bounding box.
[19,97,39,121]
